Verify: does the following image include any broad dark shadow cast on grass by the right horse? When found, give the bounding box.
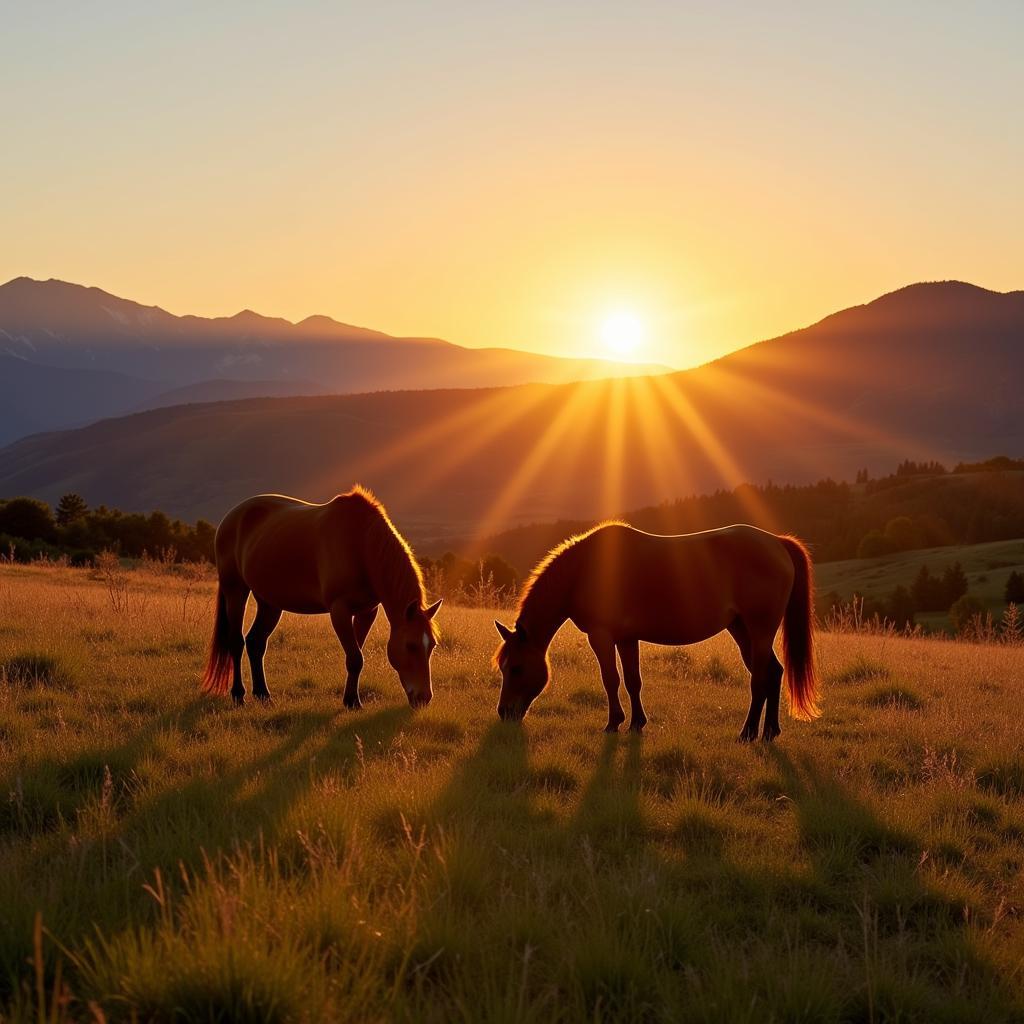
[393,723,1024,1024]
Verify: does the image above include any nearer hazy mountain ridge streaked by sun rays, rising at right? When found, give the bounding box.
[0,282,1024,541]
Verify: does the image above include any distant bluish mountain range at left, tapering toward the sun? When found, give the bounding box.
[0,278,665,443]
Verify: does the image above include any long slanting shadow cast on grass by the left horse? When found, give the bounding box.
[0,697,413,996]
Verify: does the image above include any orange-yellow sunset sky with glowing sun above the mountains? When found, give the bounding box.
[0,0,1024,368]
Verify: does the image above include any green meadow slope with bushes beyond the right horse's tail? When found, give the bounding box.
[815,540,1024,630]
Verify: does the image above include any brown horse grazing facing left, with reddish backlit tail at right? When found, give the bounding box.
[495,522,820,740]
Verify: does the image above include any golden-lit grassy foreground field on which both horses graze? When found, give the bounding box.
[0,566,1024,1024]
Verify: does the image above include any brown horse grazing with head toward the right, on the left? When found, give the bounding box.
[204,486,441,708]
